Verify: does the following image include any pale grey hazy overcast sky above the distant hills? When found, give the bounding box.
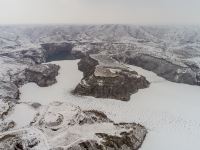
[0,0,200,24]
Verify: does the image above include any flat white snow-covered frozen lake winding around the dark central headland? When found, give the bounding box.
[18,60,200,150]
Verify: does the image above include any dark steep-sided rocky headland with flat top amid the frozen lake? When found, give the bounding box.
[74,56,149,101]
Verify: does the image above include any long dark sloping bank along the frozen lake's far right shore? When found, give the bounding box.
[125,54,200,85]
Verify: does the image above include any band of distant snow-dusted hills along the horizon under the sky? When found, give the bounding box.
[0,25,200,47]
